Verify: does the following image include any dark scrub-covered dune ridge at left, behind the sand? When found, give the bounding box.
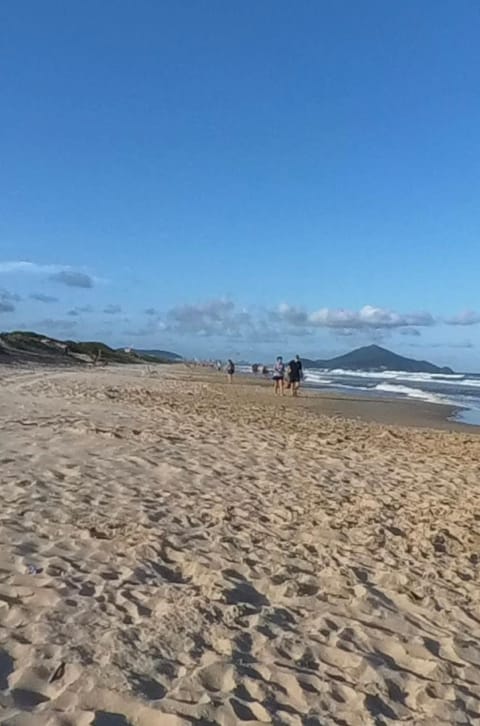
[0,330,179,365]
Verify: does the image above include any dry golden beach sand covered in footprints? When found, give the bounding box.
[0,367,480,726]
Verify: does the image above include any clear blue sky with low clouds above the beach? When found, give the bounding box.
[0,0,480,371]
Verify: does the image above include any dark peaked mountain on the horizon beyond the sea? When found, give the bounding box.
[303,345,453,375]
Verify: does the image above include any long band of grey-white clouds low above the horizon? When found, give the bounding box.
[0,261,480,364]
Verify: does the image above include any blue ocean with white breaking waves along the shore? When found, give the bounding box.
[305,368,480,425]
